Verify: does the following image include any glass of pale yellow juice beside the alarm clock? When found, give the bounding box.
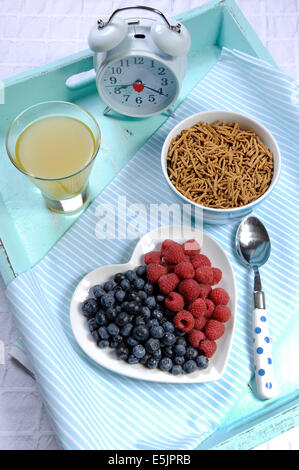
[6,101,101,214]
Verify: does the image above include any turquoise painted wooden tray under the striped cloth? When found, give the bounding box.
[0,0,299,449]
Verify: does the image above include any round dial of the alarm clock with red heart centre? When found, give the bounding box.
[99,55,178,116]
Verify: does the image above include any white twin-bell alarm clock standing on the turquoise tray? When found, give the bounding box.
[88,6,191,117]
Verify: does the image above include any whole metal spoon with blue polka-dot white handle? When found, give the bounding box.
[236,217,276,399]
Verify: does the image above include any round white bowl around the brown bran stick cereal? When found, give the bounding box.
[161,110,281,224]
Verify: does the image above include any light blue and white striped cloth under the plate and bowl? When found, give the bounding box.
[7,49,299,450]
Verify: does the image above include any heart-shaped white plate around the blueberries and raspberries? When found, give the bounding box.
[70,226,237,383]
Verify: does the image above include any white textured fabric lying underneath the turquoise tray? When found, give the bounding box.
[0,0,299,450]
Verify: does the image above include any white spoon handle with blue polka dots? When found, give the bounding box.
[253,308,275,399]
